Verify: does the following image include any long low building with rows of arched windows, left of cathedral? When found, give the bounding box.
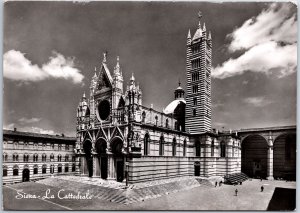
[2,129,76,184]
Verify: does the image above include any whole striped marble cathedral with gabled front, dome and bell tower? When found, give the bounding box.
[75,18,241,183]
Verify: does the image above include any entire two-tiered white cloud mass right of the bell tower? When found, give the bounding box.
[212,3,297,79]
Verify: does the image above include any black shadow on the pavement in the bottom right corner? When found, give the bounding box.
[267,187,296,211]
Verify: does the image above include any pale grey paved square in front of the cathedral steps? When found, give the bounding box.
[3,179,296,210]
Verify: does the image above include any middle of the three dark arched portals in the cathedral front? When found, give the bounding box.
[95,138,108,179]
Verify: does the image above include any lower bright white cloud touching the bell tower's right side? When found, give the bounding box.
[213,41,297,79]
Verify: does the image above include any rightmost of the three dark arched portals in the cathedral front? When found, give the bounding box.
[111,137,124,182]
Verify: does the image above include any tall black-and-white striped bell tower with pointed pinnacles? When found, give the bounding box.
[185,12,212,134]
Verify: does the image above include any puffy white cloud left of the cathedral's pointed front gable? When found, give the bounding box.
[3,50,84,84]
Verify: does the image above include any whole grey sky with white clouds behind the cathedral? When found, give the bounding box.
[3,2,297,136]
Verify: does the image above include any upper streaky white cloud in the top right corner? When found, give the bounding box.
[228,3,297,51]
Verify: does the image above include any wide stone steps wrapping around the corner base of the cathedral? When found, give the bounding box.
[37,177,213,205]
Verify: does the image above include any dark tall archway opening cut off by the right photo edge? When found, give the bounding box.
[273,134,296,180]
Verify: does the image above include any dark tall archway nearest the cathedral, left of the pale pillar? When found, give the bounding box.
[242,135,268,178]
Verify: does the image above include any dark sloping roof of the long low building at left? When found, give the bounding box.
[3,129,76,141]
